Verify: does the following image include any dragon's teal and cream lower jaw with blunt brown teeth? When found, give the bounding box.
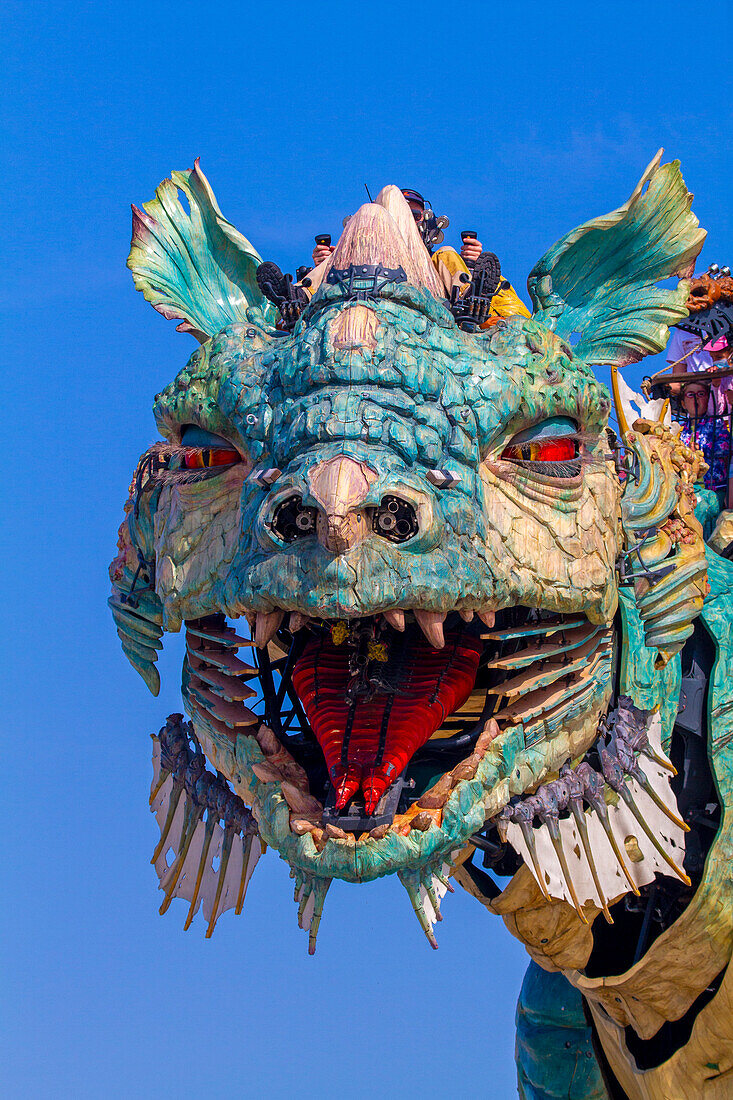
[181,617,611,882]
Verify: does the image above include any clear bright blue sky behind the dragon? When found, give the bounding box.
[0,0,733,1100]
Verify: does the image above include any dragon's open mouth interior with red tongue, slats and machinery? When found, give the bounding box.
[184,607,610,835]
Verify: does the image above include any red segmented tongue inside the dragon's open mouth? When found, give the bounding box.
[293,633,481,814]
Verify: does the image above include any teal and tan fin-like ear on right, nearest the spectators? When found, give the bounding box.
[527,150,705,366]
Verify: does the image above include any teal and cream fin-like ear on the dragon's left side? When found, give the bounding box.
[128,160,276,343]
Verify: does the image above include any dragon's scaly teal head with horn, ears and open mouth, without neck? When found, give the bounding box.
[110,150,704,947]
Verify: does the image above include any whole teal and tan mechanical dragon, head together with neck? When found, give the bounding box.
[110,154,733,1100]
